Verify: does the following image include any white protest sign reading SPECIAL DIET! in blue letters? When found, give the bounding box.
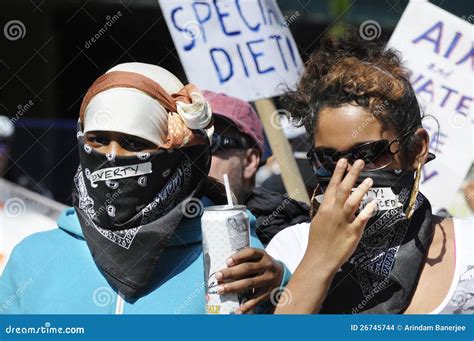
[159,0,303,101]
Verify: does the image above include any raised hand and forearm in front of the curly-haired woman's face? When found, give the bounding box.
[275,159,376,314]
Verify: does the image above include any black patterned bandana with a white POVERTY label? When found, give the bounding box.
[73,125,211,298]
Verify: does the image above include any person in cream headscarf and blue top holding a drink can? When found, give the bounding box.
[0,63,284,314]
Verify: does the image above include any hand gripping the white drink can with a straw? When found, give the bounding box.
[216,248,284,314]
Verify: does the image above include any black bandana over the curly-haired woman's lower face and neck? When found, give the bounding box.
[319,170,433,314]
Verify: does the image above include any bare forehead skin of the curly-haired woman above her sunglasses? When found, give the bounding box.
[314,104,402,169]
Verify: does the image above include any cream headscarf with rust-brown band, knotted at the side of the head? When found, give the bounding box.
[80,63,213,148]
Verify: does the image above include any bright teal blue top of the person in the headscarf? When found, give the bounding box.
[0,199,288,314]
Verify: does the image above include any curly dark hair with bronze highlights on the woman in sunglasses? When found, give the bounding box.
[281,31,423,166]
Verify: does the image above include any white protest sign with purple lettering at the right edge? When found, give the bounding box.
[389,1,474,211]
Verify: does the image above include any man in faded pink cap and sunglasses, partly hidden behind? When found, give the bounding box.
[203,91,309,245]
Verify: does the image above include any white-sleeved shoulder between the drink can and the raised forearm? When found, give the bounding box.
[266,223,310,272]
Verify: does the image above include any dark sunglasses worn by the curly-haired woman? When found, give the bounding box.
[307,139,400,176]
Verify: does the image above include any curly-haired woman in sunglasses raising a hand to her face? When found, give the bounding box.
[266,34,474,314]
